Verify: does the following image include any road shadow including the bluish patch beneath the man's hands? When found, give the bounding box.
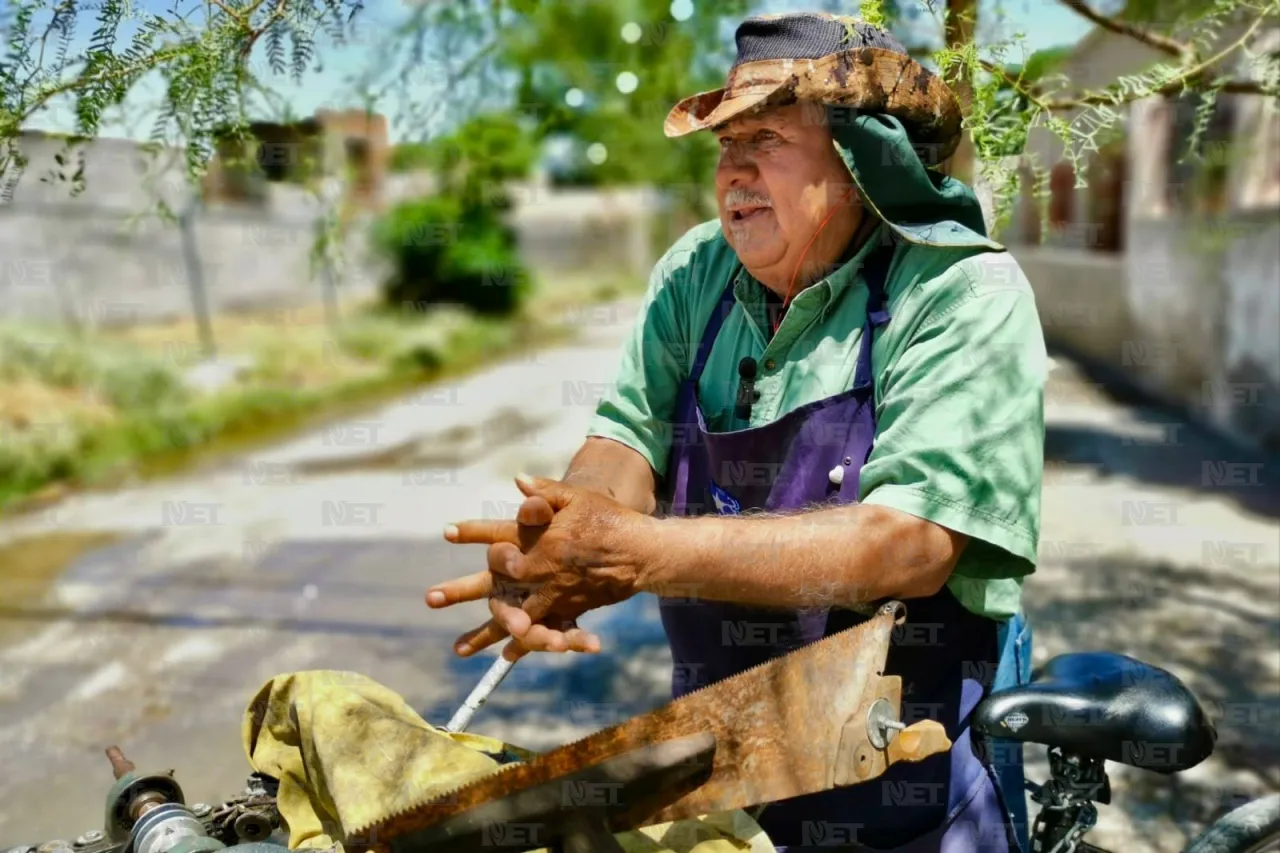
[0,532,671,749]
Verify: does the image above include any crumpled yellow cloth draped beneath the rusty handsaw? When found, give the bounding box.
[241,670,777,853]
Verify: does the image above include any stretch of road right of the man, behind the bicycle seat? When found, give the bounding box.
[1025,360,1280,853]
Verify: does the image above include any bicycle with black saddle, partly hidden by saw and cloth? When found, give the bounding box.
[10,652,1280,853]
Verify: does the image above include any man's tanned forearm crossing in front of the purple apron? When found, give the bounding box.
[634,505,966,608]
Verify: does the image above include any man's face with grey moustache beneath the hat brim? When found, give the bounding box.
[716,104,860,292]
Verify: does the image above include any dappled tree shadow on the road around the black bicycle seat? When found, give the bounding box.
[1025,545,1280,840]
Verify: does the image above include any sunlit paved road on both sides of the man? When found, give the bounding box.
[0,295,1280,853]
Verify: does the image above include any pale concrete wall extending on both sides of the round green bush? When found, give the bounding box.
[0,137,664,327]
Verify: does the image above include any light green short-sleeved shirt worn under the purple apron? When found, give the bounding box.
[590,220,1048,619]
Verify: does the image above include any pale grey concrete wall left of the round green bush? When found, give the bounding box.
[0,131,376,327]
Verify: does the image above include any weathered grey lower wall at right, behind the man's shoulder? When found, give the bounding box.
[1012,211,1280,450]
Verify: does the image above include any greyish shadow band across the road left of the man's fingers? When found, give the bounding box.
[0,530,474,643]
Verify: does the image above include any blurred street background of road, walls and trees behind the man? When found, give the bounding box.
[0,0,1280,853]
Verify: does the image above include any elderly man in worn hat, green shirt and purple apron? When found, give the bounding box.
[428,14,1047,853]
